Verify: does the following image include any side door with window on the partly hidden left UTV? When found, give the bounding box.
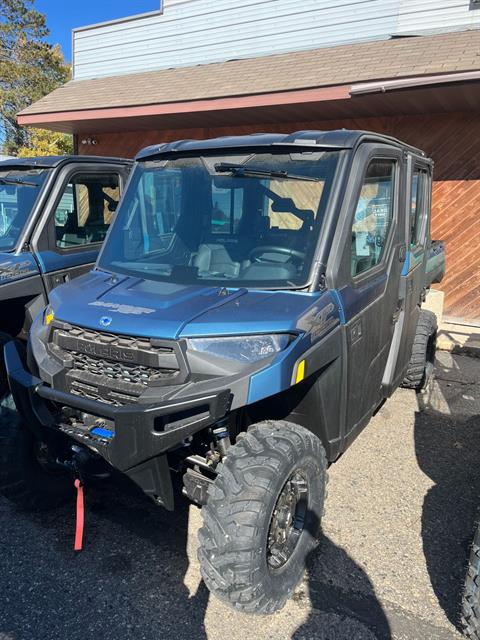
[34,164,126,290]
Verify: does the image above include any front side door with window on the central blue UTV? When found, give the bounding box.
[327,144,406,447]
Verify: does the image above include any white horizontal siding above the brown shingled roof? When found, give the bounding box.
[73,0,480,80]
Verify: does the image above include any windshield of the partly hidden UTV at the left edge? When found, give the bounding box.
[0,169,48,251]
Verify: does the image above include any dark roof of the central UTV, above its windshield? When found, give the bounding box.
[135,129,425,160]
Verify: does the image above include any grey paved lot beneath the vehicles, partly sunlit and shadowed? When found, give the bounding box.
[0,353,480,640]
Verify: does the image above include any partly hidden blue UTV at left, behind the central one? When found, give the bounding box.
[0,156,131,398]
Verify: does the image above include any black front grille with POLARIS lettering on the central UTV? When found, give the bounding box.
[49,322,186,405]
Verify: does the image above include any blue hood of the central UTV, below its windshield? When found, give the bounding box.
[50,271,318,339]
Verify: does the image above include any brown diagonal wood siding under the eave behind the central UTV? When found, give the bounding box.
[80,113,480,323]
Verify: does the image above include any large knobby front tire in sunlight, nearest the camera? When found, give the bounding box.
[198,421,327,614]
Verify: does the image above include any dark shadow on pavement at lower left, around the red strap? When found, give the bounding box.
[0,470,209,640]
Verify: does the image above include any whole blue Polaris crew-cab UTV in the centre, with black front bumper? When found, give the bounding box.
[0,131,443,613]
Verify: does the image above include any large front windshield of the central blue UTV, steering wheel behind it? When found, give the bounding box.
[98,151,340,288]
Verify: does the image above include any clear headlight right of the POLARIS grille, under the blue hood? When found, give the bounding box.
[188,334,293,362]
